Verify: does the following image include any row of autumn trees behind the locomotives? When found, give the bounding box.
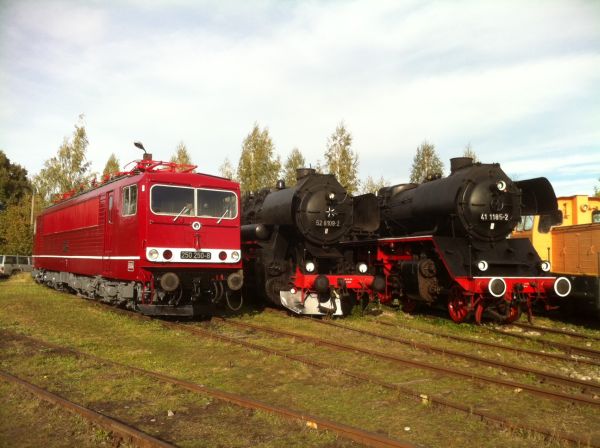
[0,115,496,254]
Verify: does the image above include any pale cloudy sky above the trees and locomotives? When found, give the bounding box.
[0,0,600,195]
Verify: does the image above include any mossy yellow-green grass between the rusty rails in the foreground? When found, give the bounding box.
[0,276,599,447]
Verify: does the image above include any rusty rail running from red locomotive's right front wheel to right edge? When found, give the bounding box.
[219,318,600,406]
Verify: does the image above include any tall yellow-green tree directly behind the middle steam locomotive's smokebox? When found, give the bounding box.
[325,122,359,194]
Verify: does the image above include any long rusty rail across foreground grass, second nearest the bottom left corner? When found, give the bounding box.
[2,330,415,448]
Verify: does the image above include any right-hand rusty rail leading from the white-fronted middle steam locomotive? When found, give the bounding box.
[302,319,600,393]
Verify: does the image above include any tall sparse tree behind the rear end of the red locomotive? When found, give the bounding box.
[33,115,94,204]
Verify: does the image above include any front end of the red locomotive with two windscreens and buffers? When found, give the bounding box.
[139,173,243,314]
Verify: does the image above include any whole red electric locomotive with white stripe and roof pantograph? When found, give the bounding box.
[33,143,243,316]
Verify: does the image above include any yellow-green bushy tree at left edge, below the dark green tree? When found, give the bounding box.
[0,192,39,255]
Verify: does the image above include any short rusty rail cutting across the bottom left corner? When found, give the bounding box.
[0,370,175,448]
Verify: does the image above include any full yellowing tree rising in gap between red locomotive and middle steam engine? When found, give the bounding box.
[237,123,281,191]
